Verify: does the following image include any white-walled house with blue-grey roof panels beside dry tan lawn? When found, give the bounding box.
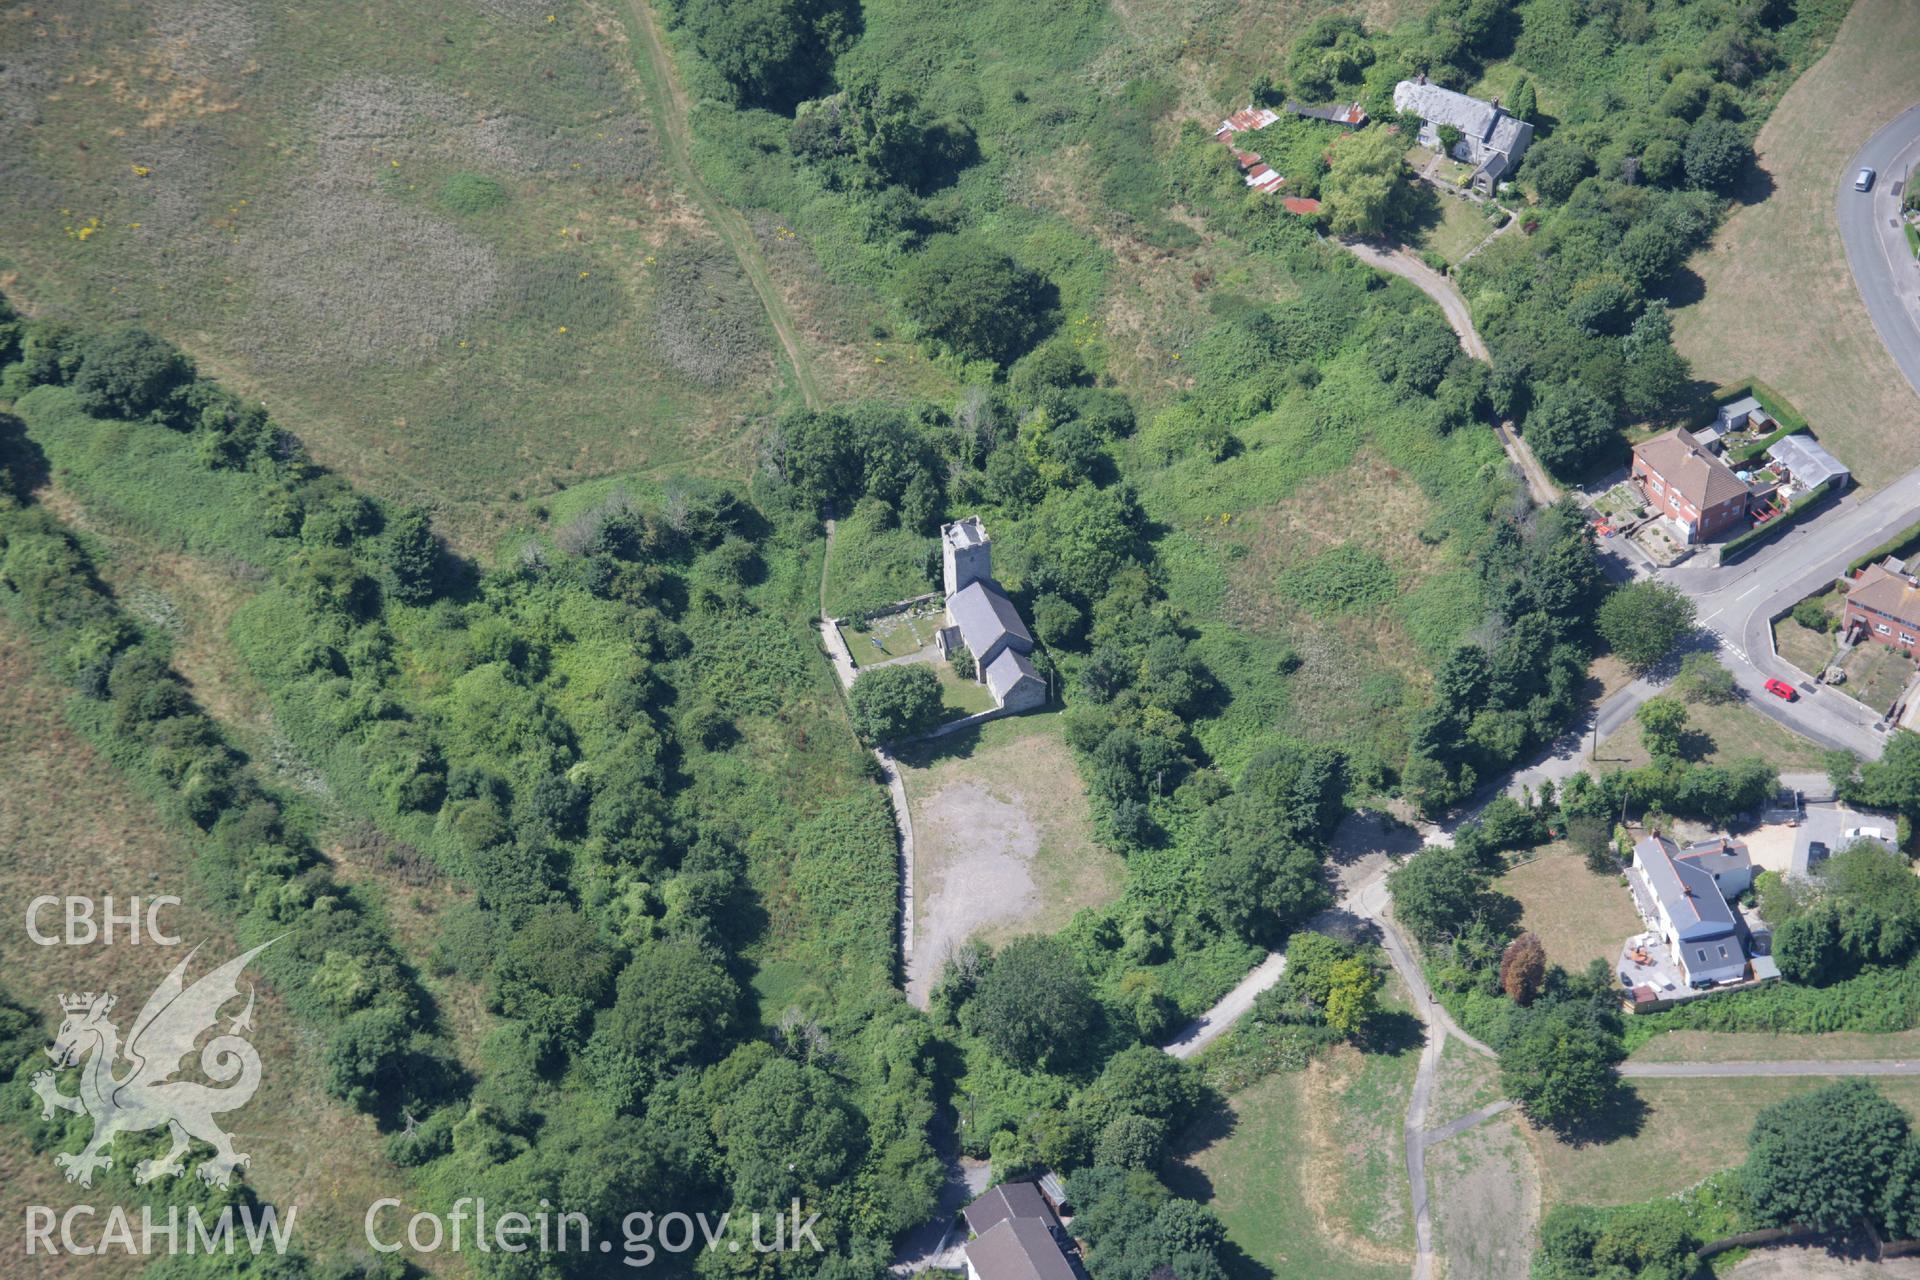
[1628,833,1751,988]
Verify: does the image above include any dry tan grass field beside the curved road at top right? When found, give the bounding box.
[1674,0,1920,486]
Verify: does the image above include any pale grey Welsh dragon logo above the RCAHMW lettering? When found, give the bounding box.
[33,942,273,1186]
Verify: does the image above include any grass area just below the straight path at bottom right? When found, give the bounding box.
[1528,1077,1920,1205]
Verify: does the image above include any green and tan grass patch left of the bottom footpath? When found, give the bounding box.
[1169,1048,1419,1280]
